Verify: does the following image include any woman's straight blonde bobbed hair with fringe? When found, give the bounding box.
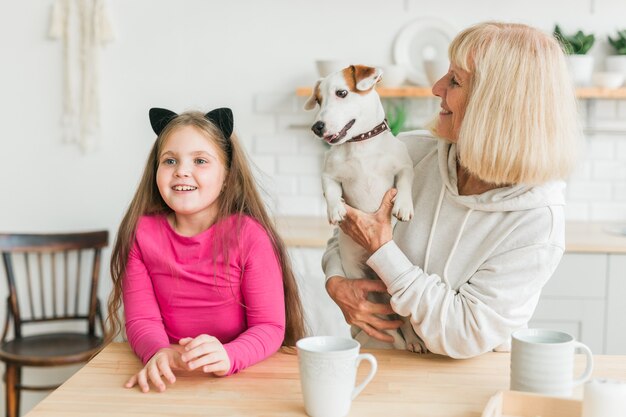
[433,22,581,185]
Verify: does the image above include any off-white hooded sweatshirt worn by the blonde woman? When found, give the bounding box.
[322,132,565,358]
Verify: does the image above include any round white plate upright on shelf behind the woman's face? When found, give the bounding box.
[393,17,457,86]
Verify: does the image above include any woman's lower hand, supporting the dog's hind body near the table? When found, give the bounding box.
[326,276,402,343]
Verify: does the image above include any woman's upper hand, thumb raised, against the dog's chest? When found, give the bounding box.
[339,188,398,255]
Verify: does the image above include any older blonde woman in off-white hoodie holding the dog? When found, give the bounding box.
[322,22,581,358]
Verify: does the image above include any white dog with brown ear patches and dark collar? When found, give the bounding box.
[304,65,416,349]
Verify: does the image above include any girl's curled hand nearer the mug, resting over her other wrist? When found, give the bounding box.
[179,334,230,376]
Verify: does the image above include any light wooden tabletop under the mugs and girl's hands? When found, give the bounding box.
[27,343,626,417]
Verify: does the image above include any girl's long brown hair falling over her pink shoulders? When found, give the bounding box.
[106,112,305,346]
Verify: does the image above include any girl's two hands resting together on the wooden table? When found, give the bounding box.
[124,334,231,392]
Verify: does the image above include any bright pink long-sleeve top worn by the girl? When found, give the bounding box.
[122,215,285,374]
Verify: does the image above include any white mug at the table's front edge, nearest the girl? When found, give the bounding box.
[296,336,378,417]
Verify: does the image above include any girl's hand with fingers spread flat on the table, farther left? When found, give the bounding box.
[124,347,186,392]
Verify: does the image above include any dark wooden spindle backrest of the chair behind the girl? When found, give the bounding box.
[0,230,109,340]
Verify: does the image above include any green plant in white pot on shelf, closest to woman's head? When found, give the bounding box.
[553,25,596,86]
